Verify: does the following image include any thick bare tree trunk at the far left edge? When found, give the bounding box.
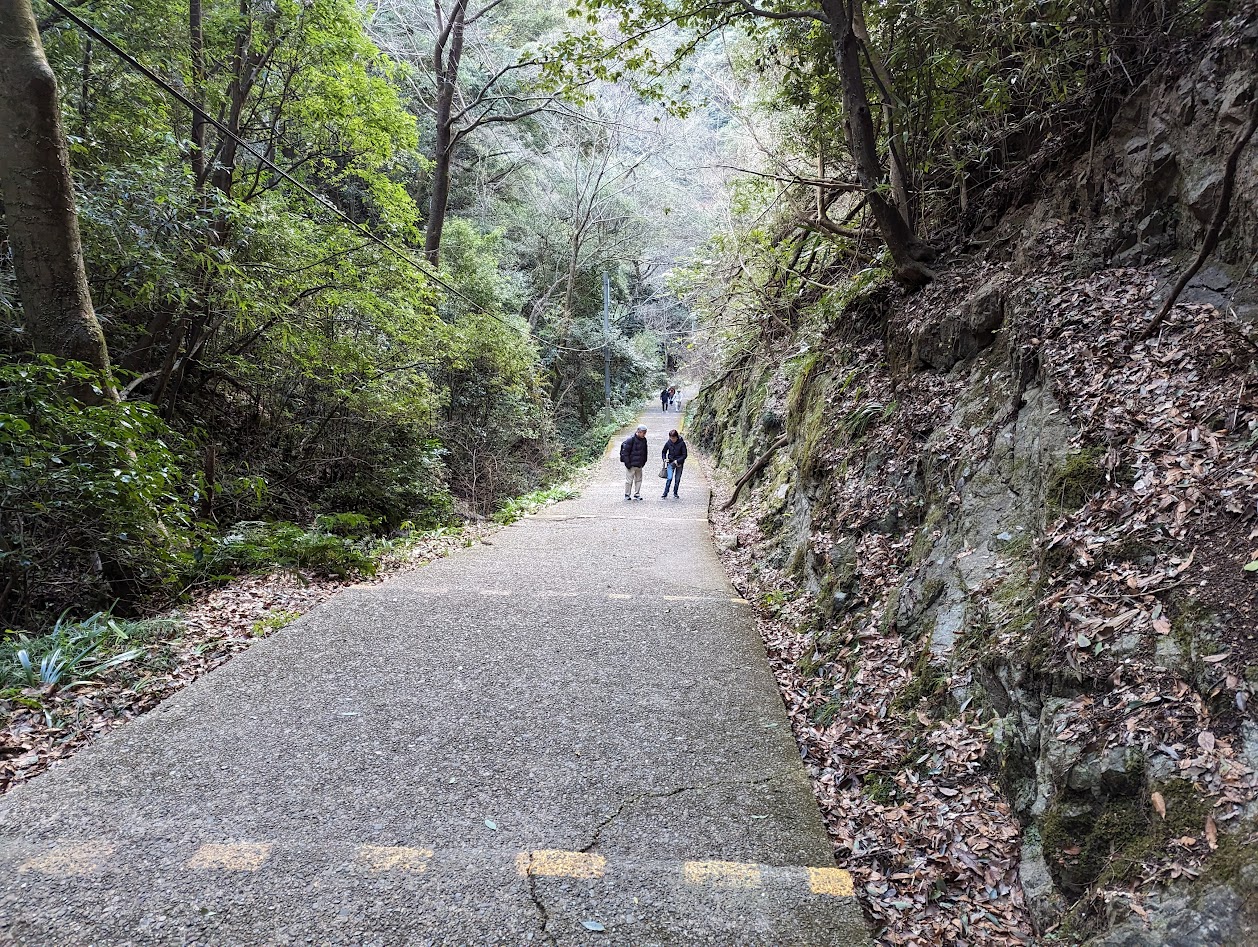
[0,0,112,379]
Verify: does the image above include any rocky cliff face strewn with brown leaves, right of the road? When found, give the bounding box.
[691,12,1258,947]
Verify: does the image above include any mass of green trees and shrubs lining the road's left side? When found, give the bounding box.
[0,0,689,628]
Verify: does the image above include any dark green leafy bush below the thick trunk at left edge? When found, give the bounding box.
[0,358,196,610]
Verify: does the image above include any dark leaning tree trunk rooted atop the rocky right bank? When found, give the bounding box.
[821,0,935,287]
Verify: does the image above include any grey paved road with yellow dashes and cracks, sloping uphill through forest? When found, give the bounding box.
[0,413,867,947]
